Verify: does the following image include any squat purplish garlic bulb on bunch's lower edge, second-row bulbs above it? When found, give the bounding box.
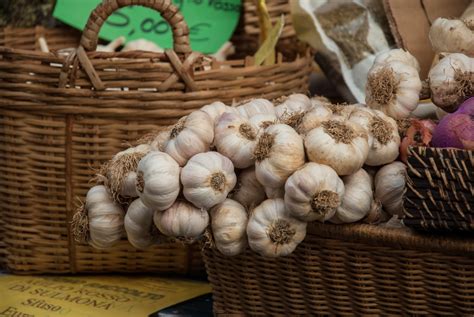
[153,200,209,241]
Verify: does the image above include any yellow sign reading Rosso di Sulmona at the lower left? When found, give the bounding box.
[0,275,211,317]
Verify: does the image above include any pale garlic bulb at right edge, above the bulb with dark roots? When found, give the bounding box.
[429,18,474,57]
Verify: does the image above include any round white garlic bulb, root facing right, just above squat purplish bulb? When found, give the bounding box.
[181,152,237,209]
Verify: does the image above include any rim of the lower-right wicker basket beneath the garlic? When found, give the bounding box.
[308,222,474,256]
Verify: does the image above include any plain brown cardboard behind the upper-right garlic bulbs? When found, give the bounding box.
[384,0,471,79]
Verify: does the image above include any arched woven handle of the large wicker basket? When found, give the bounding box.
[81,0,191,54]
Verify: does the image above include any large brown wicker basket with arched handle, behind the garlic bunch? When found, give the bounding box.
[0,0,311,273]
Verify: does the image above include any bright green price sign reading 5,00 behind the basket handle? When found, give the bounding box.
[53,0,241,54]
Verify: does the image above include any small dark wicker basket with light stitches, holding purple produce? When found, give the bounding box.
[403,147,474,232]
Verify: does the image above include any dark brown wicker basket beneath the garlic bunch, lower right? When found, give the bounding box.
[203,223,474,316]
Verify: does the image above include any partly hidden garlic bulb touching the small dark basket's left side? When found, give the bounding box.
[375,162,407,216]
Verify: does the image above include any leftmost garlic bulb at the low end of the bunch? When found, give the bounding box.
[85,185,124,249]
